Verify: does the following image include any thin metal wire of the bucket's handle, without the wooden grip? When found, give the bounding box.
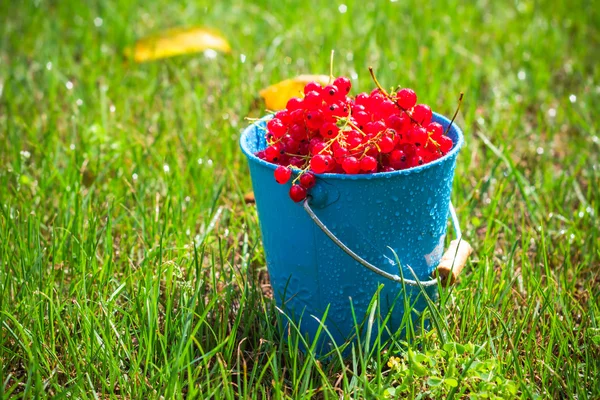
[304,198,462,286]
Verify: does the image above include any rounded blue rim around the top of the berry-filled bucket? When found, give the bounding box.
[239,112,464,180]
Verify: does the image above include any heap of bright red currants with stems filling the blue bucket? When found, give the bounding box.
[256,77,453,202]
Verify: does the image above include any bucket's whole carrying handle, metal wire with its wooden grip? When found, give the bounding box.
[303,198,473,286]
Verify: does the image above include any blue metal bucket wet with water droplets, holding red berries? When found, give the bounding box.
[240,113,463,355]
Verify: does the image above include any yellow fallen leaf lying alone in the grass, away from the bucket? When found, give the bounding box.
[125,28,231,63]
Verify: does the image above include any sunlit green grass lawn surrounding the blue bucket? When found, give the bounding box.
[0,0,600,399]
